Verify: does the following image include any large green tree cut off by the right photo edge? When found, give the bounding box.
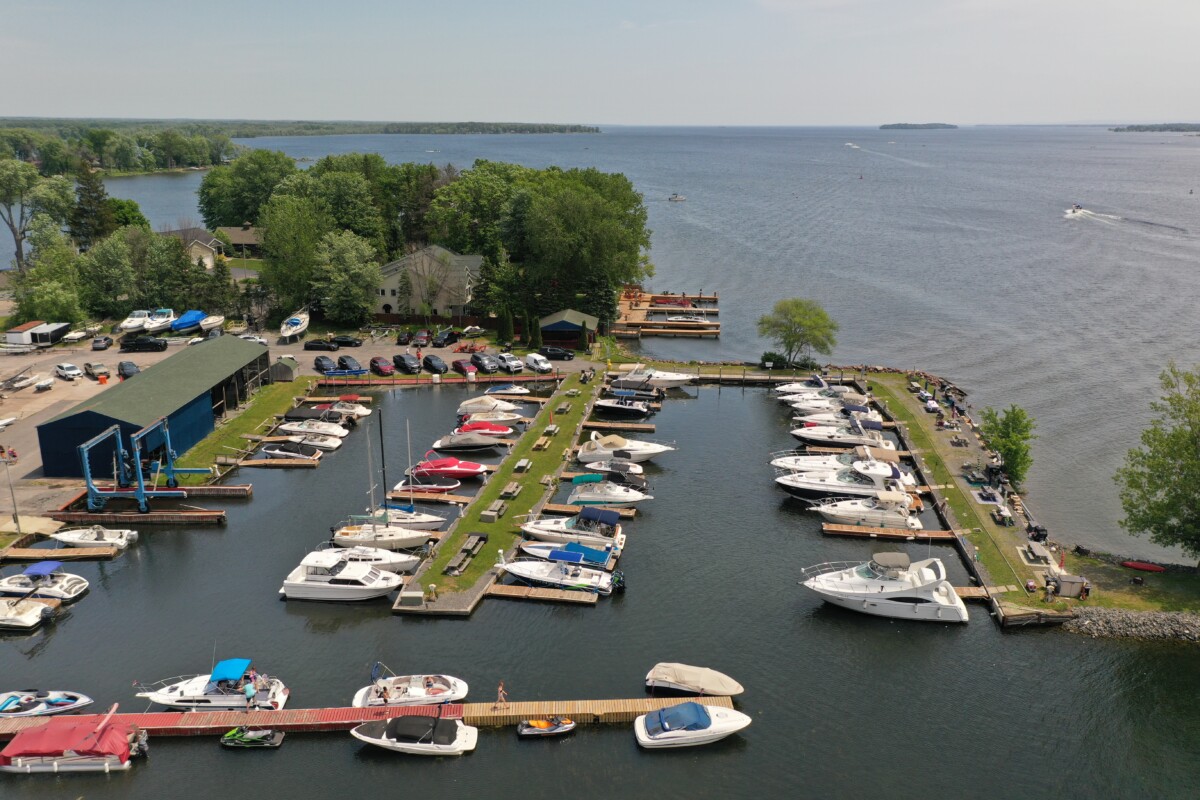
[1115,361,1200,558]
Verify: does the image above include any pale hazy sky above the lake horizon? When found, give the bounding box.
[0,0,1200,126]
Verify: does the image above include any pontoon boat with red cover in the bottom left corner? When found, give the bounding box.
[0,705,148,774]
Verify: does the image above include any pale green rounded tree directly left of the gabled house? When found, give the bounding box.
[312,230,383,325]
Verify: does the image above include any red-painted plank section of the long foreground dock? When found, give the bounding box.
[0,703,463,740]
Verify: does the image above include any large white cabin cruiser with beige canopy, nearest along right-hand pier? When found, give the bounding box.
[800,553,967,622]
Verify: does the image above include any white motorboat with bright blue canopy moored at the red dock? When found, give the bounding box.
[134,658,290,711]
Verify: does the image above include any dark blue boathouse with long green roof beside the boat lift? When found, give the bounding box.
[37,336,271,477]
